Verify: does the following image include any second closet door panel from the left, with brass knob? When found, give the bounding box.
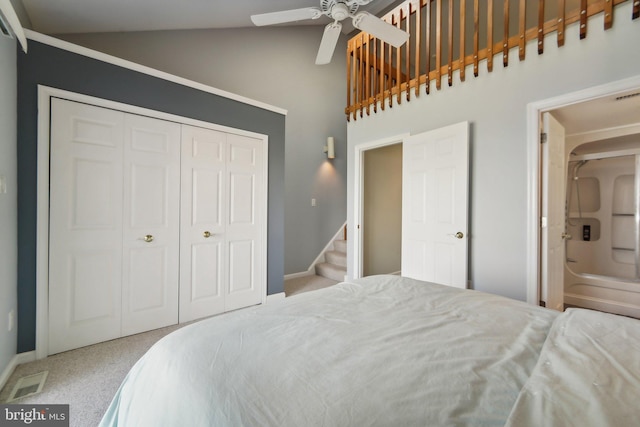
[122,114,180,335]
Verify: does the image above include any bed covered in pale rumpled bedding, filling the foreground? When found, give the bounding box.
[101,276,640,427]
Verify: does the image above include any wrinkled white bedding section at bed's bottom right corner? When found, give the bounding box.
[507,309,640,427]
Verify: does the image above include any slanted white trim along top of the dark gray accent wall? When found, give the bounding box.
[25,29,287,115]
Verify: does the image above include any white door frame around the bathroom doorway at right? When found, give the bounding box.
[527,75,640,305]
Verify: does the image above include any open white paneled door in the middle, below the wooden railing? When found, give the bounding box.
[402,122,469,288]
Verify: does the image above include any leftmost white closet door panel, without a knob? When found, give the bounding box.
[49,99,124,354]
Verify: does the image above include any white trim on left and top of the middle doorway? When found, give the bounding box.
[352,132,411,280]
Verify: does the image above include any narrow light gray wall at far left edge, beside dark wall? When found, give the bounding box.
[0,36,18,378]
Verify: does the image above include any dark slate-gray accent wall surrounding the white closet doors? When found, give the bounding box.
[16,40,285,353]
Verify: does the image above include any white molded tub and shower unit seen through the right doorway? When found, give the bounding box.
[564,155,640,318]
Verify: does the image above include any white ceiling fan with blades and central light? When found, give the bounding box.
[251,0,409,65]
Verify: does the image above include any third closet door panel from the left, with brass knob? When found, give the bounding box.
[180,126,227,323]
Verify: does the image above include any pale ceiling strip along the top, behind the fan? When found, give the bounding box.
[21,0,402,34]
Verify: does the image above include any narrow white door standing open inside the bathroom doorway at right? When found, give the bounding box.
[540,113,567,311]
